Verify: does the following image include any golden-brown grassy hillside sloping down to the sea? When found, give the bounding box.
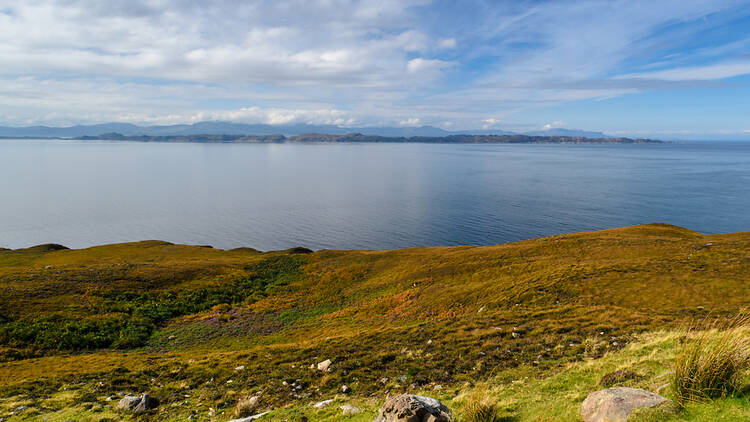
[0,224,750,421]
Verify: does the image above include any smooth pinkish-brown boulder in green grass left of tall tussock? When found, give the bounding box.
[581,387,671,422]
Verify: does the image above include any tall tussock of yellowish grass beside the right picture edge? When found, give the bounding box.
[672,316,750,406]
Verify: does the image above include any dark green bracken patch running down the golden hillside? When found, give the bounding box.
[0,255,304,350]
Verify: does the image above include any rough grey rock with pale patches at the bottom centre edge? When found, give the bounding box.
[373,394,454,422]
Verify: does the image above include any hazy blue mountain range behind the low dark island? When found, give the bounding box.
[0,121,609,139]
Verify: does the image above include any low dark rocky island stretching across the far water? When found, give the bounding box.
[73,132,664,144]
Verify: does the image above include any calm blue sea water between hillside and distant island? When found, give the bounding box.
[0,140,750,250]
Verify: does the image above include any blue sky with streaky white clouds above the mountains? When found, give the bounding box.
[0,0,750,138]
